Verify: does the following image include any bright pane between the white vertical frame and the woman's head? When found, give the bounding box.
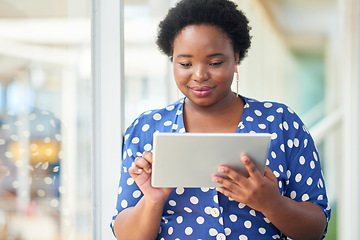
[124,0,177,126]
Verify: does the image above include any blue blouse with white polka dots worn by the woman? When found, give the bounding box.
[111,97,330,240]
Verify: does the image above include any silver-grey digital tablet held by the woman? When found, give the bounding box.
[151,133,271,187]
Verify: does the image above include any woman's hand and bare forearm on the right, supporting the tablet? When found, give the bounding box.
[213,155,326,240]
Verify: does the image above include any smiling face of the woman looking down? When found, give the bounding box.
[173,25,239,107]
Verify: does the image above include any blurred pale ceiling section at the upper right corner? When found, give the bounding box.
[260,0,338,49]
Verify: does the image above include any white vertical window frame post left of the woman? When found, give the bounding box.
[92,0,124,240]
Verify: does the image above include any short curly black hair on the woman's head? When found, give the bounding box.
[156,0,251,63]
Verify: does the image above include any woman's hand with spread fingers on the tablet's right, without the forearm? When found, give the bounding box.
[212,155,282,212]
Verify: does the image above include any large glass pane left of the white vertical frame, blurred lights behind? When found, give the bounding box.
[0,0,92,240]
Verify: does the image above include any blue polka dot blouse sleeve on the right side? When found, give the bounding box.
[282,109,331,236]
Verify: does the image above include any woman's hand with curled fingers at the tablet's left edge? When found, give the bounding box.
[129,151,172,204]
